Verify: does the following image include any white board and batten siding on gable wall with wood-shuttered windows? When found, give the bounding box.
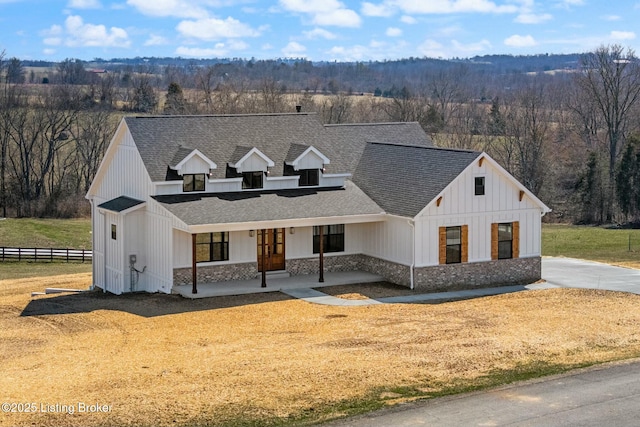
[416,156,542,267]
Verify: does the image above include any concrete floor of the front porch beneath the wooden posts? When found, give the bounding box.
[172,271,385,299]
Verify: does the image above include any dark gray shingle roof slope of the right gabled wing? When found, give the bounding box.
[353,143,482,218]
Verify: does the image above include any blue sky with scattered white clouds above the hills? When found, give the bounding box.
[0,0,640,61]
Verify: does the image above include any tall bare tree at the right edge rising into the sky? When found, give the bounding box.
[575,45,640,221]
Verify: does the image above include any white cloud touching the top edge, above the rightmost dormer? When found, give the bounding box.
[279,0,362,27]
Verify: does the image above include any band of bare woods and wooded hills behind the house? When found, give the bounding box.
[0,45,640,223]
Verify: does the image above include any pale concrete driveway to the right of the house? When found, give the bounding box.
[542,257,640,294]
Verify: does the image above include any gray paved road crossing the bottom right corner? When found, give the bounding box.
[326,361,640,427]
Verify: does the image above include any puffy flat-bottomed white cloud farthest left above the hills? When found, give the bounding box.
[42,15,131,47]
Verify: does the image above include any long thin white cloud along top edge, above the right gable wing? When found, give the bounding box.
[393,0,518,14]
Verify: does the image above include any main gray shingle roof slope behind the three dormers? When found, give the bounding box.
[124,113,346,181]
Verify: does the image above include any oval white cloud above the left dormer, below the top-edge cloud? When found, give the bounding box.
[176,17,260,40]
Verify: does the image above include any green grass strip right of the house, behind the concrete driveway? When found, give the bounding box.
[542,224,640,263]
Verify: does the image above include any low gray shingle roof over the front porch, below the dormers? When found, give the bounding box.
[154,182,382,225]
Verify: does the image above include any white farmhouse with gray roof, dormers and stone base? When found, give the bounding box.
[86,113,549,294]
